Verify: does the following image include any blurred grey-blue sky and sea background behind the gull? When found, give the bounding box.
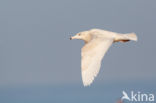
[0,0,156,103]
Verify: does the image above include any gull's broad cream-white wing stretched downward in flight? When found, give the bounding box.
[81,38,113,86]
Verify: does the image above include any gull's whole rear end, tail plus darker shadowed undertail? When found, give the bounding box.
[114,33,138,42]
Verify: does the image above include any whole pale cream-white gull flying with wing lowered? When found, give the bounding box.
[70,29,137,86]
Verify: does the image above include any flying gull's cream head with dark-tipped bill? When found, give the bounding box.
[70,31,91,42]
